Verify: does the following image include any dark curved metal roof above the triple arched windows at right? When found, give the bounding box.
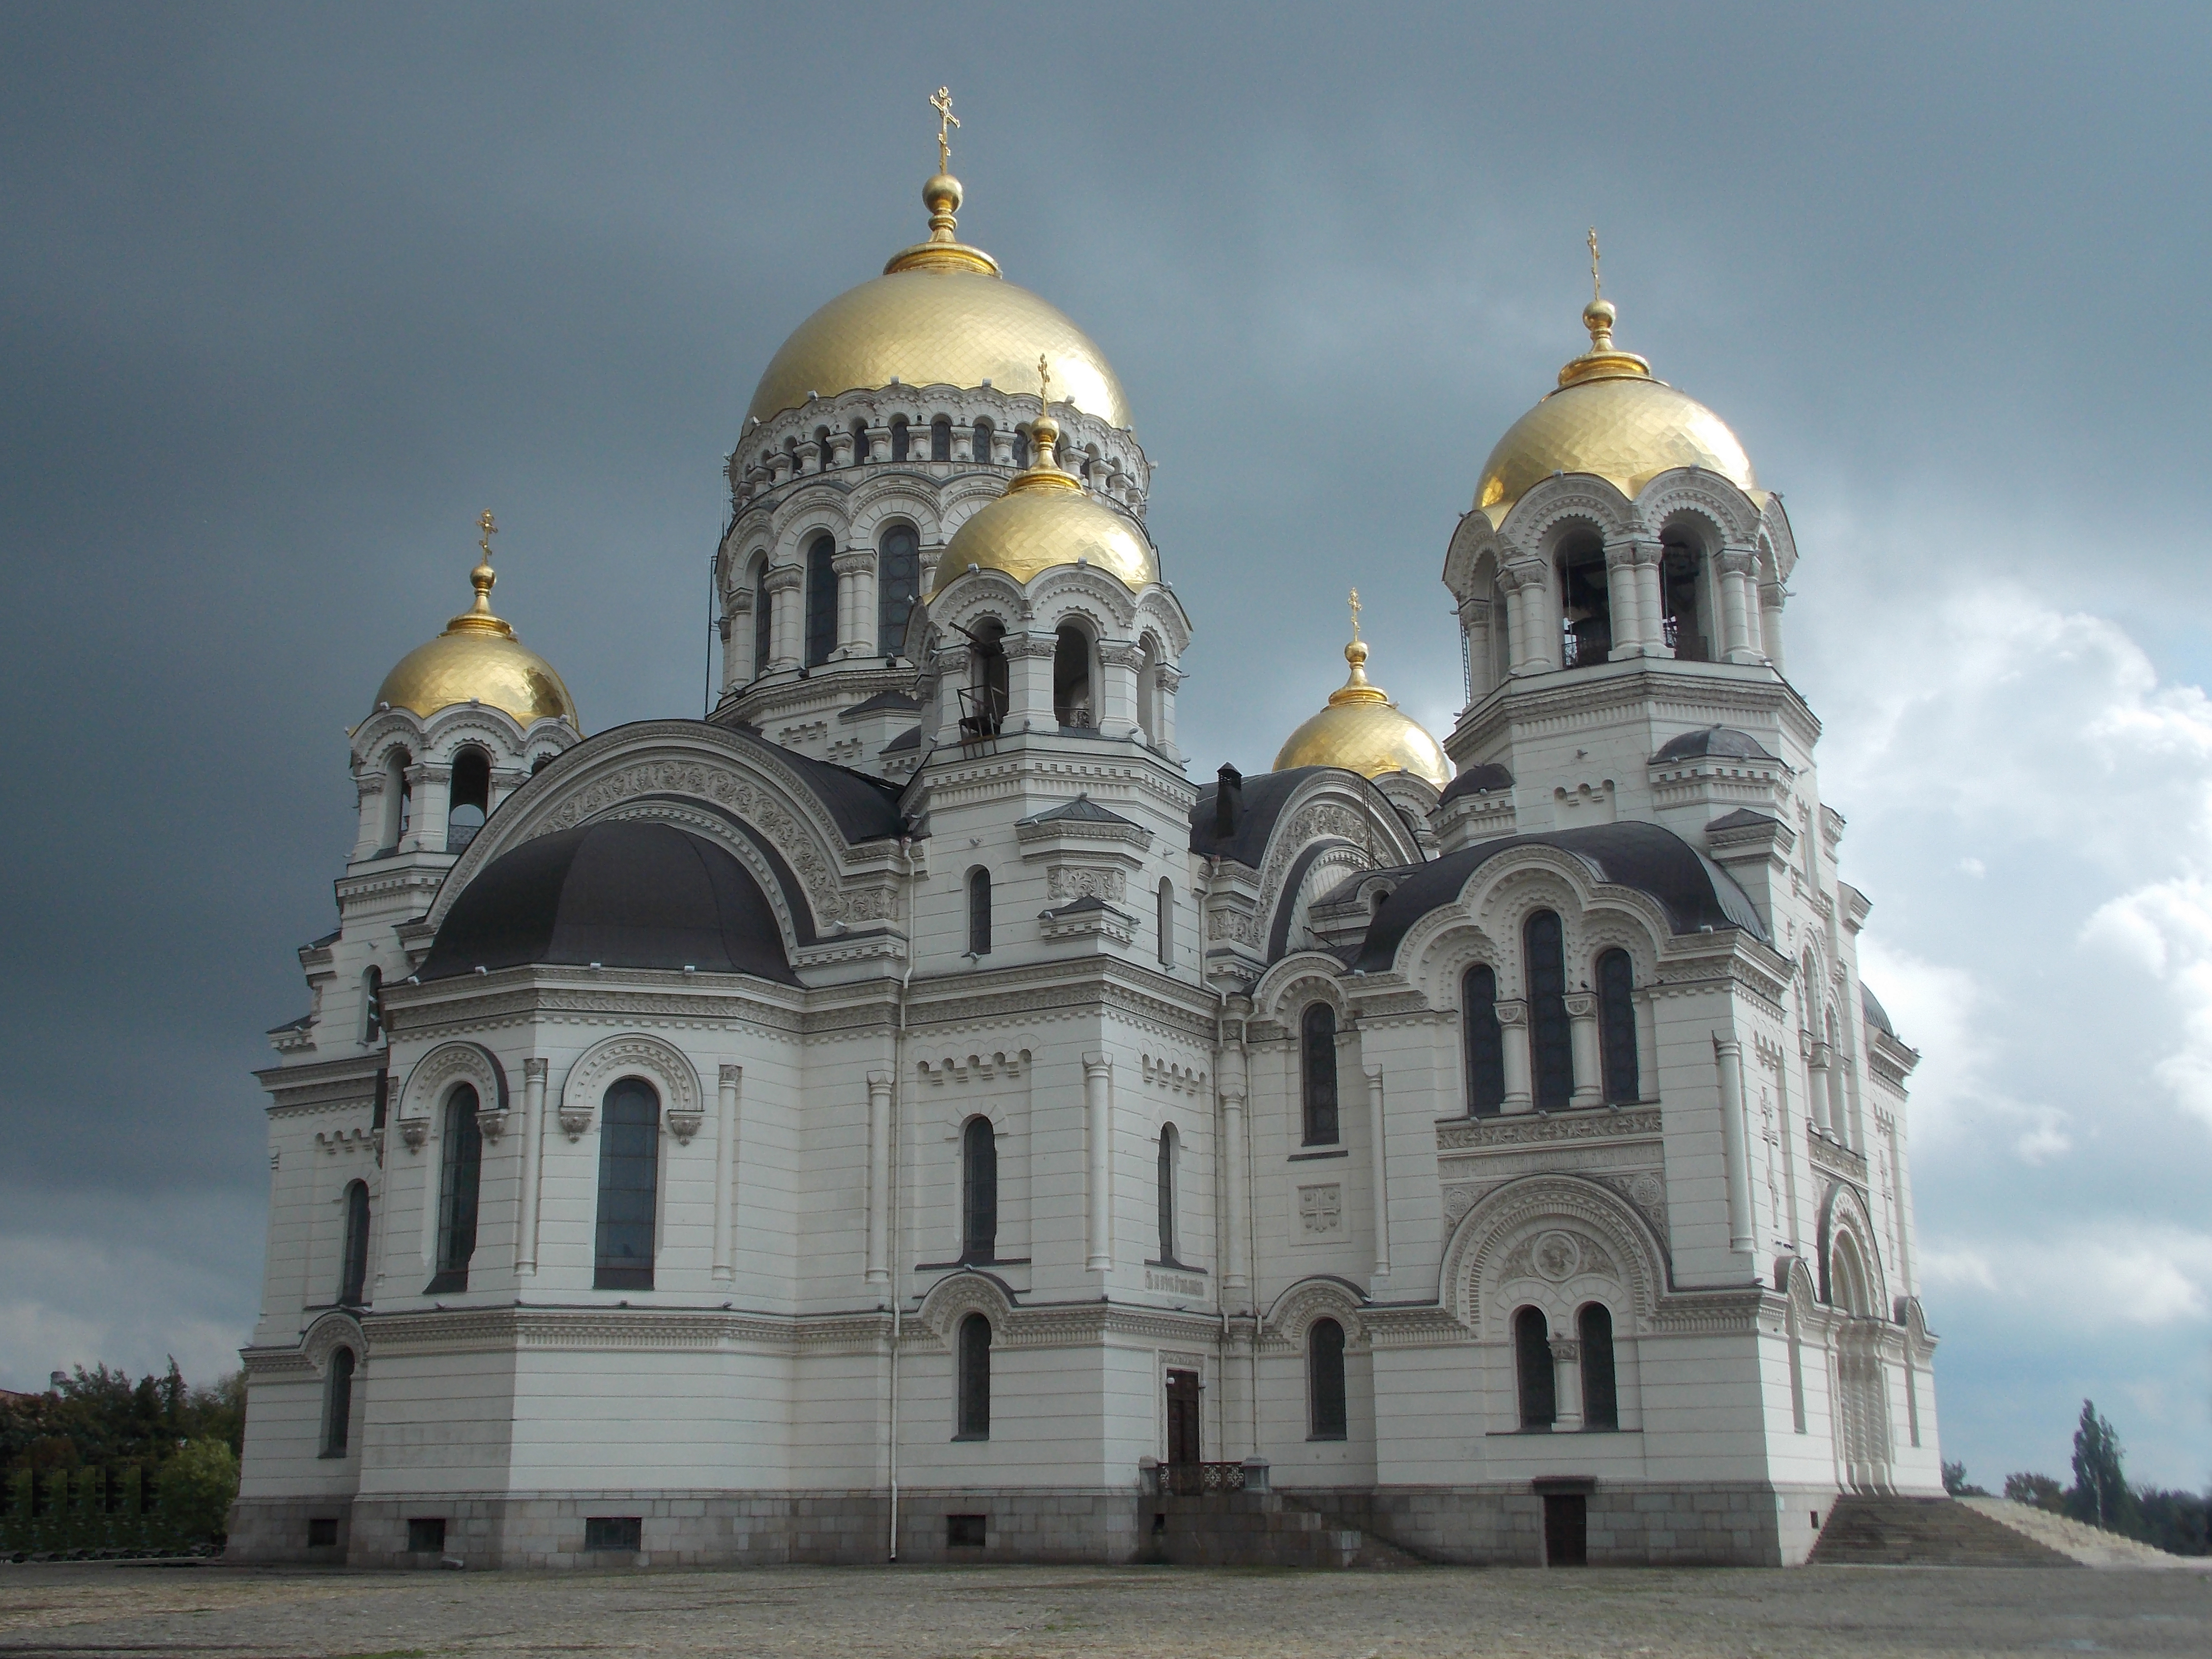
[1354,823,1768,973]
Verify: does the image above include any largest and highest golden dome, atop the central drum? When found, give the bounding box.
[750,173,1131,427]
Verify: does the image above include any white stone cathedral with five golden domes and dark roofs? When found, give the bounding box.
[230,126,1940,1566]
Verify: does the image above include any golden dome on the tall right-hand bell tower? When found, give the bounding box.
[1476,299,1759,524]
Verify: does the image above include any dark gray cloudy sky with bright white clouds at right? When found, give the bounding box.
[0,0,2212,1486]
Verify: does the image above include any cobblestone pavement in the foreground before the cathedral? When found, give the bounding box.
[0,1564,2212,1659]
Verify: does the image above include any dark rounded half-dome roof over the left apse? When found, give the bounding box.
[420,821,799,985]
